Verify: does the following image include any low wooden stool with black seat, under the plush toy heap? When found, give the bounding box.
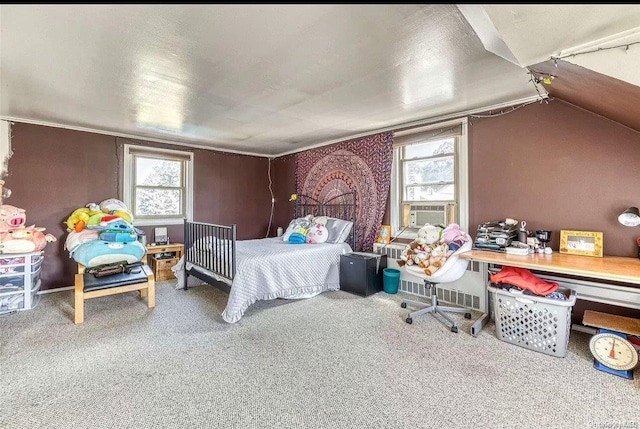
[74,264,156,324]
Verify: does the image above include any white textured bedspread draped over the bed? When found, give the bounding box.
[176,237,351,323]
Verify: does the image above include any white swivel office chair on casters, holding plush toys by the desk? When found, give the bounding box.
[400,234,473,333]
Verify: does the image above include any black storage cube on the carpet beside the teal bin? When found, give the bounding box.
[340,253,387,296]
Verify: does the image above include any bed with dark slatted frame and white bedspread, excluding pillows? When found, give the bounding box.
[176,191,357,323]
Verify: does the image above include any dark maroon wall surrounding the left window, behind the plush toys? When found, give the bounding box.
[4,123,273,289]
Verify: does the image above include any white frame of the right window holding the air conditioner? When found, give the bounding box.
[389,118,469,239]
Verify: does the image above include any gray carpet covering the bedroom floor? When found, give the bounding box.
[0,282,640,429]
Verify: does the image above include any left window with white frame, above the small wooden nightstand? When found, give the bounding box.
[122,144,193,226]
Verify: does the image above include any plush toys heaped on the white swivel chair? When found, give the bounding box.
[397,223,468,276]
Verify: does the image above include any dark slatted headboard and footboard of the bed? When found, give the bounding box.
[183,191,358,290]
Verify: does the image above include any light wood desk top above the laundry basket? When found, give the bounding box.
[460,250,640,285]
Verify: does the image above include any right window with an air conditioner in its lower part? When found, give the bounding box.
[390,120,468,238]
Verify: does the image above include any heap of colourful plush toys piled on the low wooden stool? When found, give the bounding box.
[65,198,146,267]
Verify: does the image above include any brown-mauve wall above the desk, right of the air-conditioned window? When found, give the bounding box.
[469,101,640,257]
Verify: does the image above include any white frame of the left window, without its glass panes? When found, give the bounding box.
[120,144,194,226]
